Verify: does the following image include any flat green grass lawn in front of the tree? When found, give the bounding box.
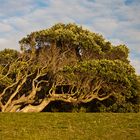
[0,113,140,140]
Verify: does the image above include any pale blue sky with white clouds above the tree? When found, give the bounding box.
[0,0,140,74]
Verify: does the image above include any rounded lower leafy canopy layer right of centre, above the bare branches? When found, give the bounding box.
[63,59,136,88]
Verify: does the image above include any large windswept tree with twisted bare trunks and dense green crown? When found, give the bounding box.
[0,23,140,112]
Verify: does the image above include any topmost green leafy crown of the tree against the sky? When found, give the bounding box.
[20,23,128,62]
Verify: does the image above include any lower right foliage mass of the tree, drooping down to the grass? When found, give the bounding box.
[64,59,140,112]
